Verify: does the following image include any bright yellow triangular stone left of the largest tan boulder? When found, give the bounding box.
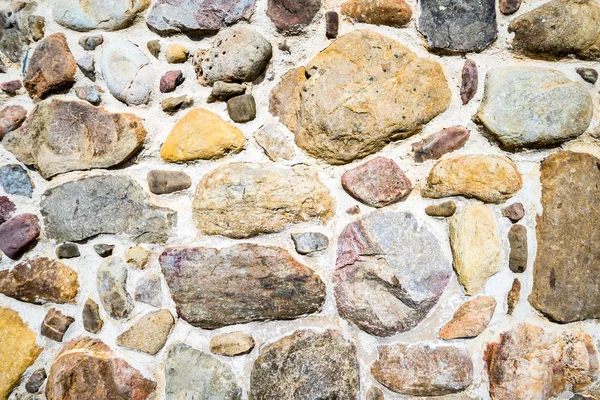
[160,108,245,162]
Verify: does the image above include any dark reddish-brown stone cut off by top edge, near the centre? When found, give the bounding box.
[267,0,321,34]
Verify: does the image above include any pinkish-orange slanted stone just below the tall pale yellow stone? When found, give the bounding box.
[438,296,496,340]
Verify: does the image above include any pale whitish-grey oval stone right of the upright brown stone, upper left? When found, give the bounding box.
[101,40,156,106]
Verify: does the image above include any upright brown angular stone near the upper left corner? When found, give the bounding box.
[23,33,77,98]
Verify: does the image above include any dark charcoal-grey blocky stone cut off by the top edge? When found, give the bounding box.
[418,0,498,53]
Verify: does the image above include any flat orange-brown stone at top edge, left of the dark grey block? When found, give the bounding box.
[342,0,412,28]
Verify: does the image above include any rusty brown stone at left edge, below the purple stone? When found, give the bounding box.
[0,257,79,304]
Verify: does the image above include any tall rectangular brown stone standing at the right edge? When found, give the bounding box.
[529,151,600,322]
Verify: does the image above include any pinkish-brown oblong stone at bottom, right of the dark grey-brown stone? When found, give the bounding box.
[371,343,473,396]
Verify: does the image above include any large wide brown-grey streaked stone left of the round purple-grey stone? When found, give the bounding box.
[159,244,325,329]
